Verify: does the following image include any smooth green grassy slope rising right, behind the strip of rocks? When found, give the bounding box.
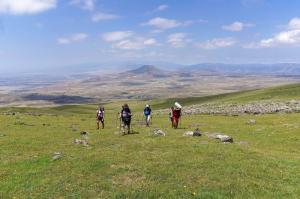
[155,81,300,108]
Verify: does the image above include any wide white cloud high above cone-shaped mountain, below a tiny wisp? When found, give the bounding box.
[143,17,182,29]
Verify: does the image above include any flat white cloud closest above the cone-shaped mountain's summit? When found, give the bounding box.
[113,37,157,50]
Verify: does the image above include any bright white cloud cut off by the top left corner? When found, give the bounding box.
[0,0,57,15]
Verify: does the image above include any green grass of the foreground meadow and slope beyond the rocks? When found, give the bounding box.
[0,85,300,199]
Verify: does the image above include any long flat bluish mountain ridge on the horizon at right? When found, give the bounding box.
[182,63,300,75]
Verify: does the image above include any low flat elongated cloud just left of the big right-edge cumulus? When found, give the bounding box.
[197,37,237,49]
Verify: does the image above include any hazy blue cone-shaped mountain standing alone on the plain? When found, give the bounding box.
[125,65,169,78]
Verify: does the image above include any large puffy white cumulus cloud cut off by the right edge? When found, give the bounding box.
[244,18,300,48]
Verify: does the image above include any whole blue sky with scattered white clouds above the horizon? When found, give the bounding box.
[0,0,300,72]
